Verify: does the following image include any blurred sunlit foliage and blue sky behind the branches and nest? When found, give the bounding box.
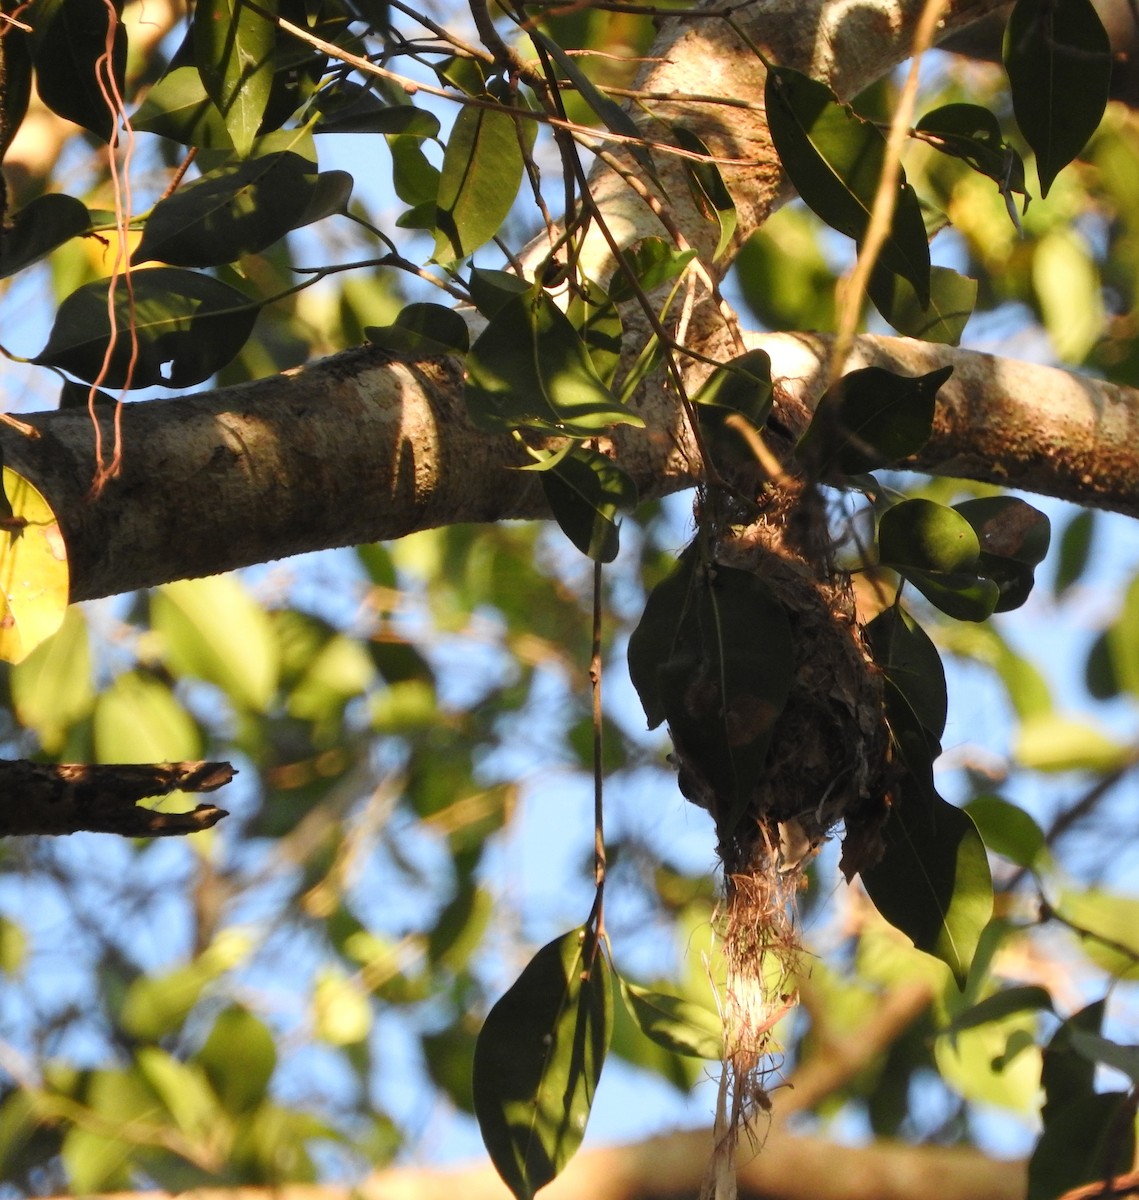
[0,2,1139,1194]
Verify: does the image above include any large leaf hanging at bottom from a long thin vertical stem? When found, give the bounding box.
[474,929,613,1200]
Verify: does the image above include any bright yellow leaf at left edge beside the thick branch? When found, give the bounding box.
[0,467,70,662]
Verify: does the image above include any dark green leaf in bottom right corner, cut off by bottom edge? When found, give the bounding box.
[1026,1092,1135,1200]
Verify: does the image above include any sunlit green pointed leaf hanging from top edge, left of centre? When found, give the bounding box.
[193,0,277,157]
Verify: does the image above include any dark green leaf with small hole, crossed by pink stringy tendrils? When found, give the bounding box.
[32,266,259,388]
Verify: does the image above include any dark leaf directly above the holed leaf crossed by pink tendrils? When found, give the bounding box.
[133,152,317,266]
